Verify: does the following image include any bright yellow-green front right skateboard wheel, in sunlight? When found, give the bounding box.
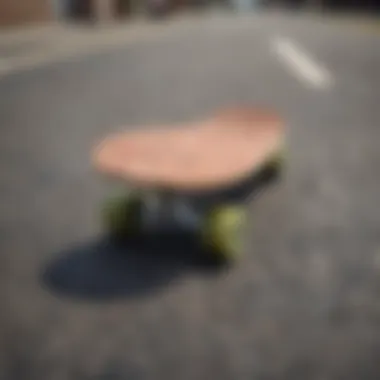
[202,205,245,262]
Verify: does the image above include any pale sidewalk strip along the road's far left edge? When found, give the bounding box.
[0,19,181,78]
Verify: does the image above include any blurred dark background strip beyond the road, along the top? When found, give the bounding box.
[0,0,380,25]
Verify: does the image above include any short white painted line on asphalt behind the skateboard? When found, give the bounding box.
[272,37,333,89]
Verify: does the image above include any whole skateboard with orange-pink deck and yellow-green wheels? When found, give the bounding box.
[93,107,284,261]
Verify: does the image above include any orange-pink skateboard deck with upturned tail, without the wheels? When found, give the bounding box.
[93,108,284,191]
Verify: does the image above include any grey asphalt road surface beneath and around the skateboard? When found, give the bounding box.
[0,14,380,380]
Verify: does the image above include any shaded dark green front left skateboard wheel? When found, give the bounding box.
[102,194,142,238]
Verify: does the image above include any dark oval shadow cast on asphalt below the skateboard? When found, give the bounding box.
[42,234,212,301]
